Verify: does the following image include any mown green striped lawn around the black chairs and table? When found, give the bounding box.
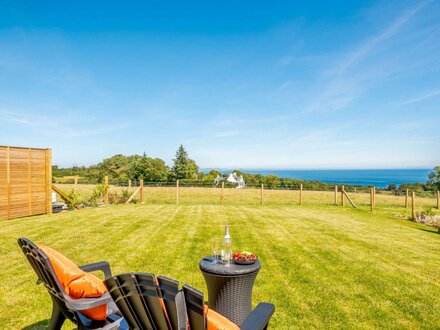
[0,204,440,329]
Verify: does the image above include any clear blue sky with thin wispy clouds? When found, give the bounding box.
[0,1,440,168]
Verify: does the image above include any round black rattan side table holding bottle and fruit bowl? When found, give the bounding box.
[199,257,261,325]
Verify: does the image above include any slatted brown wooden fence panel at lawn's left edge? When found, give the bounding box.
[0,146,52,219]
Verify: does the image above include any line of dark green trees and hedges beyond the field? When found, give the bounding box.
[52,145,440,194]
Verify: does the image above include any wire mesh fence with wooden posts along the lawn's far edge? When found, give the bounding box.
[53,181,439,208]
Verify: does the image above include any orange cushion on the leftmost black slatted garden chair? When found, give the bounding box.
[38,245,107,320]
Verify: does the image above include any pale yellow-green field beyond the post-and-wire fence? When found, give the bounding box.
[56,184,437,211]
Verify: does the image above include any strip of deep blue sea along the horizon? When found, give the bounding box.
[203,168,432,188]
